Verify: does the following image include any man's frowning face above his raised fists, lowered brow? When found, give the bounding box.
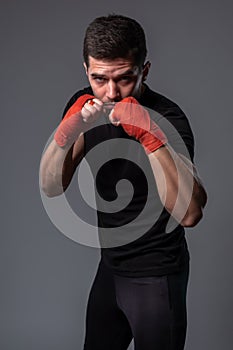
[84,56,148,102]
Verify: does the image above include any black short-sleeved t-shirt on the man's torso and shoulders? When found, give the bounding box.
[63,85,194,277]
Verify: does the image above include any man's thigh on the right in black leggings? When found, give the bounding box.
[115,266,187,350]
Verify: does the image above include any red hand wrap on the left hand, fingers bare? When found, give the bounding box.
[54,94,95,147]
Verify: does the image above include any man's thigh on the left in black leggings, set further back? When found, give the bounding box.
[84,263,132,350]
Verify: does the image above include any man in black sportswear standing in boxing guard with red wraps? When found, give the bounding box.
[41,15,206,350]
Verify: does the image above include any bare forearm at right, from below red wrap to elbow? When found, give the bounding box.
[148,146,207,226]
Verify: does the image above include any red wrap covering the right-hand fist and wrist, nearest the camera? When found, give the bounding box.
[112,97,167,154]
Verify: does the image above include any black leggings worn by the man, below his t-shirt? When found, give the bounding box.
[84,262,189,350]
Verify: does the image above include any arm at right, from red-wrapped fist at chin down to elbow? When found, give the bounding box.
[110,97,206,226]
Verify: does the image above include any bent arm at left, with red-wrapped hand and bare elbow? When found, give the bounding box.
[40,94,103,197]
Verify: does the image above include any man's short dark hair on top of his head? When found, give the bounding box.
[83,14,147,66]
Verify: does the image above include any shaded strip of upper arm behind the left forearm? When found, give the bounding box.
[62,134,84,191]
